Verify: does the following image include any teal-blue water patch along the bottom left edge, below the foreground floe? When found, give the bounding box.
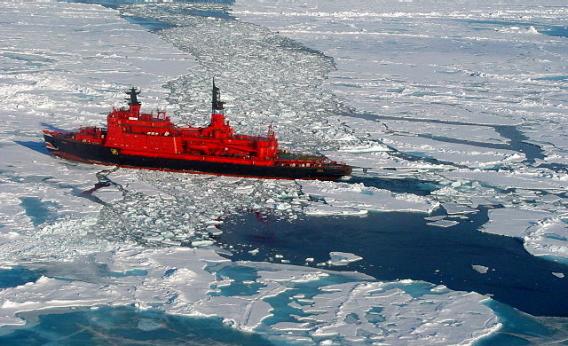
[0,307,271,346]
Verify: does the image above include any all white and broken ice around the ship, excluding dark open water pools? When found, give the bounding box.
[0,0,568,345]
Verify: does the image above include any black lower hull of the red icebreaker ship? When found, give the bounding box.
[44,134,351,180]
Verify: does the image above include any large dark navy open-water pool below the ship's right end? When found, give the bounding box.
[218,208,568,316]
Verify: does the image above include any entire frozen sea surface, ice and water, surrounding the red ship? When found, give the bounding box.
[0,1,568,345]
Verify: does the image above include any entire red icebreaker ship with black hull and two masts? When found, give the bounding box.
[44,83,351,179]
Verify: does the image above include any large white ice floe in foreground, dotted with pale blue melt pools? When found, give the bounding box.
[0,247,506,344]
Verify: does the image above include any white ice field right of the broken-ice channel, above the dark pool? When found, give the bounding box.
[232,0,568,258]
